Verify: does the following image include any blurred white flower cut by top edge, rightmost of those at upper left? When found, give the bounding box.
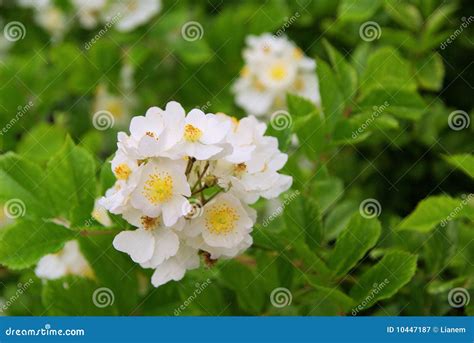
[105,0,161,32]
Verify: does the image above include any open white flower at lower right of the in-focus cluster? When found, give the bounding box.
[184,193,255,256]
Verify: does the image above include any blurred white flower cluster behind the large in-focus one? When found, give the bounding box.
[233,33,320,116]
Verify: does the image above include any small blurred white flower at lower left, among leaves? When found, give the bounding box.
[35,241,93,280]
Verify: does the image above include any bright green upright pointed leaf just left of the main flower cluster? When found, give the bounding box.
[45,138,96,226]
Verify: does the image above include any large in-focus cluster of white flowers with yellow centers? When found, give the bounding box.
[99,102,292,287]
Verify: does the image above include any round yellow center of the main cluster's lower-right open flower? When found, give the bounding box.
[205,204,239,235]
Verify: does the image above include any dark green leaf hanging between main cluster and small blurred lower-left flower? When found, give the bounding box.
[79,235,138,315]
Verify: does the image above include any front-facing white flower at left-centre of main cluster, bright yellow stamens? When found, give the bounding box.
[130,158,191,226]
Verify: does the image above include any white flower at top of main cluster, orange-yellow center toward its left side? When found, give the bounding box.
[168,109,231,160]
